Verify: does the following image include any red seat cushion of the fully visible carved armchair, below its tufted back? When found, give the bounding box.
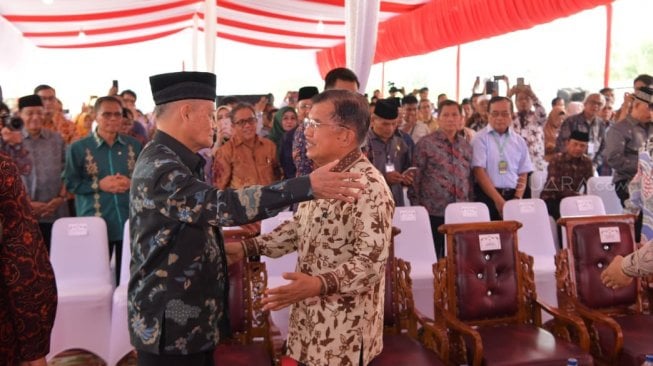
[477,325,593,366]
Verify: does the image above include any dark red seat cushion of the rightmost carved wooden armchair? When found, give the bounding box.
[596,314,653,366]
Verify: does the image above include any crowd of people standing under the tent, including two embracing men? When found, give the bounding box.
[0,68,653,365]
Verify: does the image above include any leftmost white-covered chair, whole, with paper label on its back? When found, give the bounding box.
[47,217,113,361]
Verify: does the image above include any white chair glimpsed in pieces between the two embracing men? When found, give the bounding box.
[261,211,297,339]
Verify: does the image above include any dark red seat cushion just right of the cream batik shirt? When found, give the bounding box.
[369,334,445,366]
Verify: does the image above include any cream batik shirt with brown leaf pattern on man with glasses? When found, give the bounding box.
[239,151,394,366]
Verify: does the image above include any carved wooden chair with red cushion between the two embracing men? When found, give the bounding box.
[214,230,276,366]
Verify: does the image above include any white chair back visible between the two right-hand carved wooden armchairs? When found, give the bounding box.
[503,198,556,258]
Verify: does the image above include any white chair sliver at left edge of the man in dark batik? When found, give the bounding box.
[107,220,134,366]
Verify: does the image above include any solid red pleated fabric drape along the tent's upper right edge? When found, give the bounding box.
[316,0,613,76]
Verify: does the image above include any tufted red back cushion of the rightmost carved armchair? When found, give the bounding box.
[573,222,637,309]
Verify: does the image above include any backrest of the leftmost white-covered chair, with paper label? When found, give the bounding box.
[50,216,112,284]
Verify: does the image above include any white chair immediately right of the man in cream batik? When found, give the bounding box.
[392,206,438,317]
